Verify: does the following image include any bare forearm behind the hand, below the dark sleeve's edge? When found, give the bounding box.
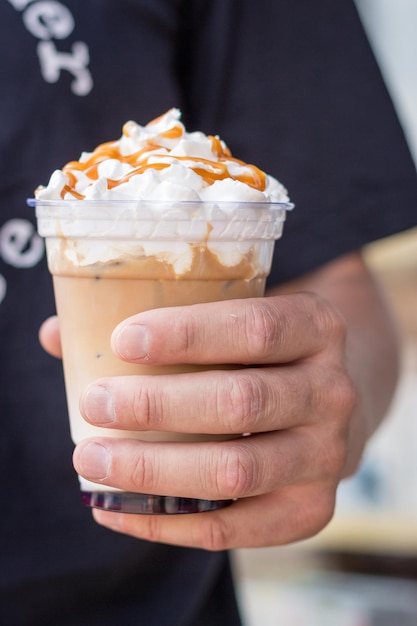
[268,253,398,475]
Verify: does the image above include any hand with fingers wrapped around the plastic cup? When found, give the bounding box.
[65,293,355,550]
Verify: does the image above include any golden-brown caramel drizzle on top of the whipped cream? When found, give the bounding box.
[61,120,266,200]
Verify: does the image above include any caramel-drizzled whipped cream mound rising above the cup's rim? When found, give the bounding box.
[35,108,288,202]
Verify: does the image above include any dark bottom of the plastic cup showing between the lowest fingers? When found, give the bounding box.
[81,491,234,515]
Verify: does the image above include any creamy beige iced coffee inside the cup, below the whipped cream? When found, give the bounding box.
[52,238,265,443]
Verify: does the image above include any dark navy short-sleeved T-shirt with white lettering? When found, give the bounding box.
[0,0,417,626]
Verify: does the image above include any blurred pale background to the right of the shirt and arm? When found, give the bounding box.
[235,0,417,626]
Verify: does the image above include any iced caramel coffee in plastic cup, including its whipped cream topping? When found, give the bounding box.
[29,111,292,514]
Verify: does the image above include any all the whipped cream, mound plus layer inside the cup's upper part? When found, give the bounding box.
[33,109,292,276]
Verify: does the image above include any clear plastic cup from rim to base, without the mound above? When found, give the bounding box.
[29,200,292,514]
